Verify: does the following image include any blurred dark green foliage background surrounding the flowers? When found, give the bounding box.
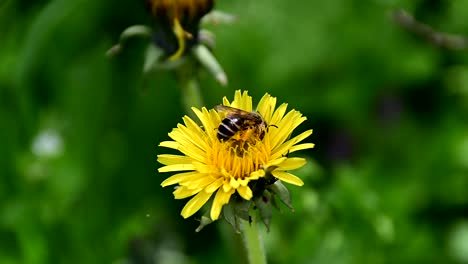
[0,0,468,264]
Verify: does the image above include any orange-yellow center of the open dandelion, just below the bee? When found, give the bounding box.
[210,137,270,179]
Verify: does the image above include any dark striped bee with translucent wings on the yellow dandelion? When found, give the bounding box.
[215,105,268,142]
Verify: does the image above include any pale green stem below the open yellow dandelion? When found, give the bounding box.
[241,217,267,264]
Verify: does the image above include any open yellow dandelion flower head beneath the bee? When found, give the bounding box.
[158,91,314,220]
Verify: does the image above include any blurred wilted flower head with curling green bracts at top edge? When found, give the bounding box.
[106,0,229,86]
